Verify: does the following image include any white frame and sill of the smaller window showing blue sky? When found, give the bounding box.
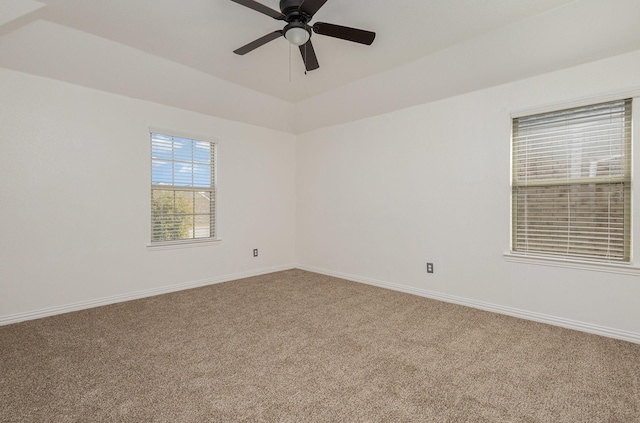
[147,128,221,250]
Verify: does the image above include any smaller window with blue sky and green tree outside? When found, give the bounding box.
[151,133,216,243]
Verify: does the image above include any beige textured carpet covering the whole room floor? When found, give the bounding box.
[0,270,640,423]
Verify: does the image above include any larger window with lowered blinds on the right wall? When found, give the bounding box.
[511,100,631,262]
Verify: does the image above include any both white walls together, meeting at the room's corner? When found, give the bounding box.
[0,46,640,342]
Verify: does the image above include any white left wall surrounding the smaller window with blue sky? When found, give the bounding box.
[0,69,296,323]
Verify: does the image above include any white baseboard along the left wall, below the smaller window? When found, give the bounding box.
[0,264,296,326]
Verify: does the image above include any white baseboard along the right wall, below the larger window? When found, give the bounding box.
[296,264,640,344]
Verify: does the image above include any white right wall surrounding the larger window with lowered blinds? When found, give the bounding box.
[296,51,640,342]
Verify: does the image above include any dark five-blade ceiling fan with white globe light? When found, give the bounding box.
[231,0,376,71]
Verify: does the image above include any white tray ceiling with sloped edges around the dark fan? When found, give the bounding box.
[0,0,640,132]
